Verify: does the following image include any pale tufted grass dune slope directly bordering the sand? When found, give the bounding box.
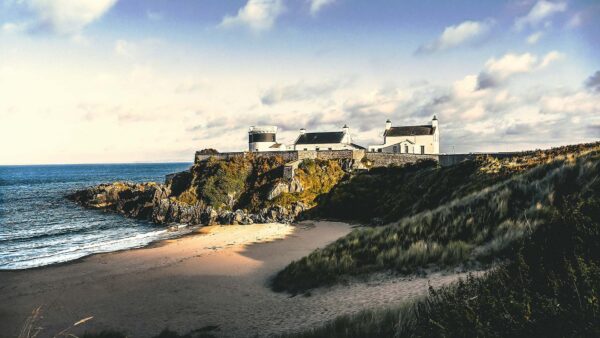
[273,143,600,293]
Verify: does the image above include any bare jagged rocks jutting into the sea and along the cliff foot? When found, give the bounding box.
[67,182,306,225]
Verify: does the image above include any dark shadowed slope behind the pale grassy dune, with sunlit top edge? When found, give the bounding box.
[309,142,600,223]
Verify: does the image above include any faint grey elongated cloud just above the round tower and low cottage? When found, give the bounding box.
[260,80,352,106]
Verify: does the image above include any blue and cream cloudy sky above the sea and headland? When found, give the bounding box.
[0,0,600,165]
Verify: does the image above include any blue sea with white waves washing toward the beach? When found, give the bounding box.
[0,163,191,270]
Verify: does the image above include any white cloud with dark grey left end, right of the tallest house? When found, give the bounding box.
[477,51,563,89]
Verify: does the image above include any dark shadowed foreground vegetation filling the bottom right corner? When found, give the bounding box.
[282,195,600,338]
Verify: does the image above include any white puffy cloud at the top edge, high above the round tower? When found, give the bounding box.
[219,0,285,32]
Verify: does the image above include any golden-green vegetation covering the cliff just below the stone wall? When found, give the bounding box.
[172,154,344,211]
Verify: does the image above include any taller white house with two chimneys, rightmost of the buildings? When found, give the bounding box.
[369,116,440,154]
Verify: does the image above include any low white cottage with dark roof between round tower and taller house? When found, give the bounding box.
[294,125,364,150]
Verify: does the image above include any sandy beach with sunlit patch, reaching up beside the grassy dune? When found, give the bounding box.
[0,222,468,337]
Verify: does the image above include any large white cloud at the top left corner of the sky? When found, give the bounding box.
[18,0,117,35]
